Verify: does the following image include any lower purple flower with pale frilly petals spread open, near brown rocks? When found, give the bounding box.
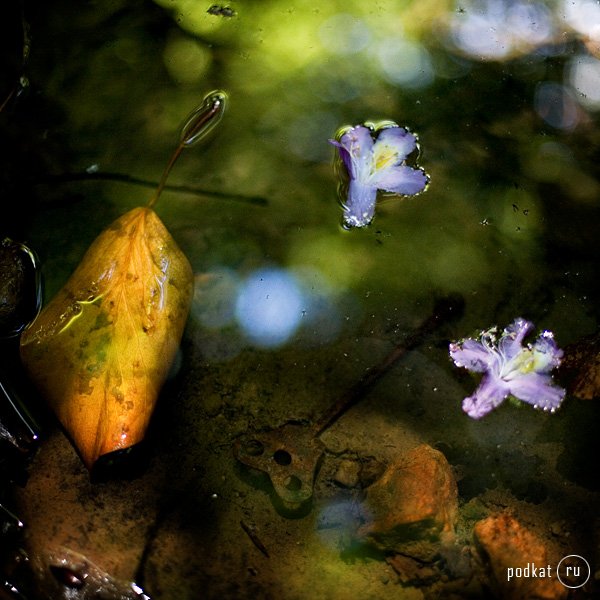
[450,318,565,419]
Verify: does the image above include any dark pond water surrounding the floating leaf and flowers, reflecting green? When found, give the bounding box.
[0,0,600,600]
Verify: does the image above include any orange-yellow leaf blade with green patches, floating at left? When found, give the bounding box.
[21,208,193,469]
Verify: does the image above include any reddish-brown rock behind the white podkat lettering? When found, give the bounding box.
[473,514,567,600]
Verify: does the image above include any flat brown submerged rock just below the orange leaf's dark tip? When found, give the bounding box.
[14,430,159,600]
